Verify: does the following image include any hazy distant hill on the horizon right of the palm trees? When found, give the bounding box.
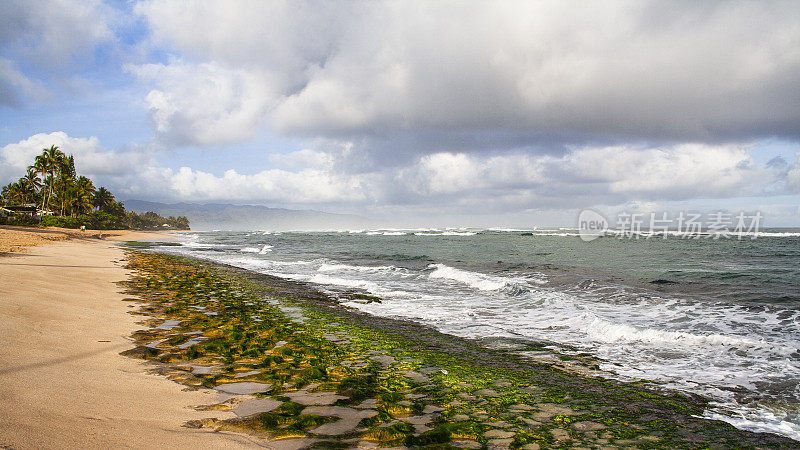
[123,200,368,231]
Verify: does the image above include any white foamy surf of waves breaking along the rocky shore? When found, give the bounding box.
[165,234,800,438]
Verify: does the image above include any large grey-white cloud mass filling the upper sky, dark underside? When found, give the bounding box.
[136,0,800,149]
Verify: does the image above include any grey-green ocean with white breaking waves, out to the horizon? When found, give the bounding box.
[158,229,800,440]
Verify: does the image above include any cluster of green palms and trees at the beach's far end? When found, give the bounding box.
[0,145,189,230]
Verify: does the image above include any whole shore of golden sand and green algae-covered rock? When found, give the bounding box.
[0,232,800,449]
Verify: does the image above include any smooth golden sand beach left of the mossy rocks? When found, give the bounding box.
[0,228,268,448]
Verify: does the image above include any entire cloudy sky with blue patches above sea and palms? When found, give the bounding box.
[0,0,800,227]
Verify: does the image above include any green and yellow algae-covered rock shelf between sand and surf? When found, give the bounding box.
[119,251,794,448]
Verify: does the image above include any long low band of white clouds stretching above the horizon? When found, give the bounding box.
[0,132,800,217]
